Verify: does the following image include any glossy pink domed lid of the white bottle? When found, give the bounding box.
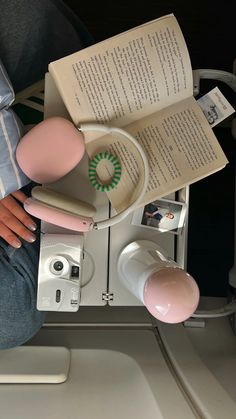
[143,268,200,323]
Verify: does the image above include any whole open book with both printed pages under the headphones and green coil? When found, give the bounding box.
[49,15,227,212]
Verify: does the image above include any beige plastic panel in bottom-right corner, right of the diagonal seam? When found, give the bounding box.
[158,302,236,419]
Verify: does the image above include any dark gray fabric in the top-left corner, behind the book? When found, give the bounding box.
[0,0,92,93]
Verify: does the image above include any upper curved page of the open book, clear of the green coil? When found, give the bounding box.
[49,15,193,135]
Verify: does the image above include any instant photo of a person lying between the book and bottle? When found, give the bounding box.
[131,199,186,234]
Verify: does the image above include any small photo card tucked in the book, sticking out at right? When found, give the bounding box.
[197,87,235,127]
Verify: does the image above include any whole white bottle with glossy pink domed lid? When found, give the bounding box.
[118,240,200,323]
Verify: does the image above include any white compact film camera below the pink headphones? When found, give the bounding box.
[37,233,83,312]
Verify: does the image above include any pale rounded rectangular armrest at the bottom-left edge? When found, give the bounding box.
[0,346,70,384]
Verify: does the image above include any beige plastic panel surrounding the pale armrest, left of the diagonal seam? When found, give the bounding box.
[0,330,196,419]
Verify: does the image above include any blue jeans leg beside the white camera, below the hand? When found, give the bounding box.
[0,233,45,349]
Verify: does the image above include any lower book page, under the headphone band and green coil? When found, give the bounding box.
[86,97,227,212]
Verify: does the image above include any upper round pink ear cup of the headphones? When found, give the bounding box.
[16,116,85,183]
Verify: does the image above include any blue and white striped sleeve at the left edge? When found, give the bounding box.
[0,60,30,199]
